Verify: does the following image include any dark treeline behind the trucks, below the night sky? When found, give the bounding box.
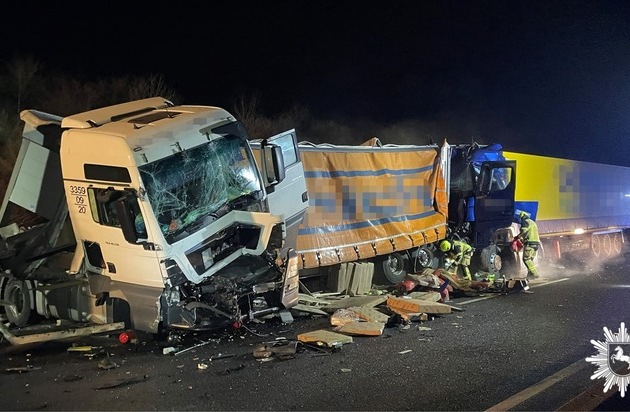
[0,57,484,198]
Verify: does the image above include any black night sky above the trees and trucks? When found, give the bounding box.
[0,0,630,166]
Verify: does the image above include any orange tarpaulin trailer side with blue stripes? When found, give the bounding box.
[297,145,448,268]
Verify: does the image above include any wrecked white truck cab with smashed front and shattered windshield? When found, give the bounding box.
[0,97,308,333]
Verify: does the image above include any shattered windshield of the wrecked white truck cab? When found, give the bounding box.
[139,135,262,243]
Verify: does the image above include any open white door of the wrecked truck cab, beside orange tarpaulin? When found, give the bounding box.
[251,129,308,248]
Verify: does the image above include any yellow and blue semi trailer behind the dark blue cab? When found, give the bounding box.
[504,151,630,260]
